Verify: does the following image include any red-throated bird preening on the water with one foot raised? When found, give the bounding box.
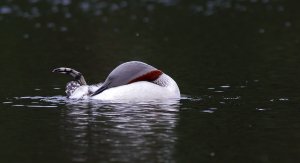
[52,61,180,101]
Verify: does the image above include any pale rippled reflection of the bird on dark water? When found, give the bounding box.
[61,101,179,162]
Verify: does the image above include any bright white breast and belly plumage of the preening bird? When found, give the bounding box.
[70,74,180,101]
